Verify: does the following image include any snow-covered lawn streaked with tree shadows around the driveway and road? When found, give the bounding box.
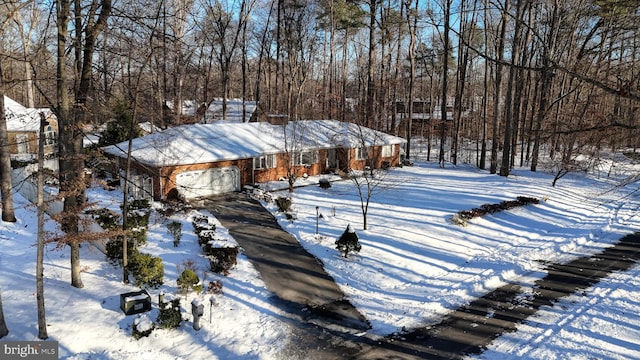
[0,163,640,360]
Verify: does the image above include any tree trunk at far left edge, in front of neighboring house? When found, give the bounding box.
[0,64,16,222]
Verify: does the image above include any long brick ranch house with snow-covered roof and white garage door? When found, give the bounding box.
[103,120,406,200]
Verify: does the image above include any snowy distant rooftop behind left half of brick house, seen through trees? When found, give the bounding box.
[167,99,257,124]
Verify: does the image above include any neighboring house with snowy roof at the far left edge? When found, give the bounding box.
[4,95,58,161]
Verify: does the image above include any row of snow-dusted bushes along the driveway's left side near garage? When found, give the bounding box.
[192,215,238,275]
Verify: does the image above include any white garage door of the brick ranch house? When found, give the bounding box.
[176,166,240,199]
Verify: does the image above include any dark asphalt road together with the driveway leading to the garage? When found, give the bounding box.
[205,194,640,360]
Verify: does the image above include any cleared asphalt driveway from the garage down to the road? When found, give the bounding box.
[204,193,369,332]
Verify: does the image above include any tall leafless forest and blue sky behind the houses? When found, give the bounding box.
[0,0,640,175]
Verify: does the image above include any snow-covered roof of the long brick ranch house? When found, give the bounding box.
[104,120,405,167]
